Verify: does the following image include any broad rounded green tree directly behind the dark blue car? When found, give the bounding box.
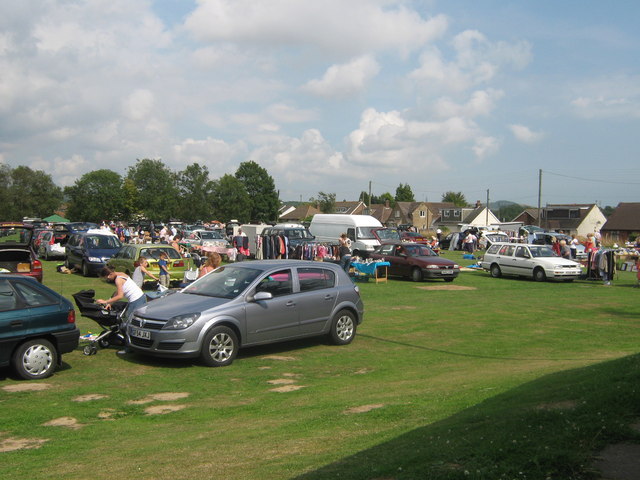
[64,169,124,222]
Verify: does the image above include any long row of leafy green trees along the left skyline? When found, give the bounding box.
[0,159,280,223]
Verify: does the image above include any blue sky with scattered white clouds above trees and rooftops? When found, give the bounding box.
[0,0,640,206]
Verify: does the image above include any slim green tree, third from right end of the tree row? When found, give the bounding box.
[177,163,214,222]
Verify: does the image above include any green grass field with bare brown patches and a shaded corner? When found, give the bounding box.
[0,252,640,480]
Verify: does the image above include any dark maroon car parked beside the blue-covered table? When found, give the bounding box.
[369,242,460,282]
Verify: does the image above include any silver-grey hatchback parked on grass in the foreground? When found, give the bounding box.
[127,260,364,367]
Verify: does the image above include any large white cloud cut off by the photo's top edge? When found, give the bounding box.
[185,0,447,56]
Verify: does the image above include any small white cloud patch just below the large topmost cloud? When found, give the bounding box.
[303,55,380,98]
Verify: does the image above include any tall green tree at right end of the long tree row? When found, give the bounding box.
[236,160,280,223]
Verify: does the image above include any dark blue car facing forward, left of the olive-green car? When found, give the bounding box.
[65,230,122,277]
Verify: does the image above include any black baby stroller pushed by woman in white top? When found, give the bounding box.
[72,290,127,355]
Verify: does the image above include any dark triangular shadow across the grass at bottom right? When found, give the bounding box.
[296,354,640,480]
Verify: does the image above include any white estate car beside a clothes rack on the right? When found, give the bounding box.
[480,243,582,282]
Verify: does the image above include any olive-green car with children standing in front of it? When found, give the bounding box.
[107,243,190,282]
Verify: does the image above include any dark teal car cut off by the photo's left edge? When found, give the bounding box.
[0,274,80,380]
